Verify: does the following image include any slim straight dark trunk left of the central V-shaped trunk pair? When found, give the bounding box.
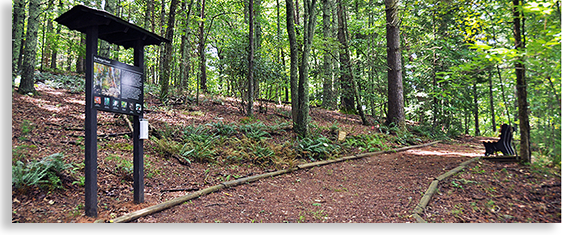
[246,0,254,117]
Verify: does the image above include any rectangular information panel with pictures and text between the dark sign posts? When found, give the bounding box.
[93,56,144,115]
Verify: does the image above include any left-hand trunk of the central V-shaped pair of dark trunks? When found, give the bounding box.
[285,0,299,124]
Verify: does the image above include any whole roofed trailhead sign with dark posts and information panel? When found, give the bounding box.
[55,5,169,217]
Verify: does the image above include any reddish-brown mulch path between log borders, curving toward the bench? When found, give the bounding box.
[137,143,483,223]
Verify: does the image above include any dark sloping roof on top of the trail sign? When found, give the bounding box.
[55,5,169,49]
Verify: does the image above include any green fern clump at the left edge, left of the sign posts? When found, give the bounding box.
[12,153,72,189]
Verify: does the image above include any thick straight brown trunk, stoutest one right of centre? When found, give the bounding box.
[384,0,405,128]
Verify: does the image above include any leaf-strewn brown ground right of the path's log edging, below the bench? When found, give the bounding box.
[423,160,560,223]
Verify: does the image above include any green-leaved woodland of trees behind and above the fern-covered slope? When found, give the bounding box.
[12,0,561,162]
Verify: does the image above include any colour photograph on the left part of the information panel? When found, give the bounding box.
[94,63,121,98]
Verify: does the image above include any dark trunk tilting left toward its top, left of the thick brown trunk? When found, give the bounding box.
[336,0,355,113]
